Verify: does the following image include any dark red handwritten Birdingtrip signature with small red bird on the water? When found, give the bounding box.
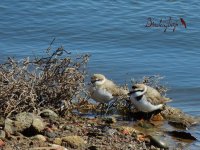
[145,17,187,32]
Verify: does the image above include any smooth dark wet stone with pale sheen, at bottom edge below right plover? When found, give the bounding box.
[149,135,169,149]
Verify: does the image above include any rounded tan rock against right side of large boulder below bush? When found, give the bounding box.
[32,116,45,132]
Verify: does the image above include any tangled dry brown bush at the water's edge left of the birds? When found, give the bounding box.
[0,45,89,116]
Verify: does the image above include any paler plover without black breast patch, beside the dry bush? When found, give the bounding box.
[89,74,128,112]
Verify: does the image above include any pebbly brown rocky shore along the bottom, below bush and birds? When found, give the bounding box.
[0,107,198,150]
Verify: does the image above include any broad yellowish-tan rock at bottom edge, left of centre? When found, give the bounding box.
[62,136,85,148]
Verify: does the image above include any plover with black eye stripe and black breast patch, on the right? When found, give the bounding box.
[129,84,171,113]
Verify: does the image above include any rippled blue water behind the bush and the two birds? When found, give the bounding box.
[0,0,200,148]
